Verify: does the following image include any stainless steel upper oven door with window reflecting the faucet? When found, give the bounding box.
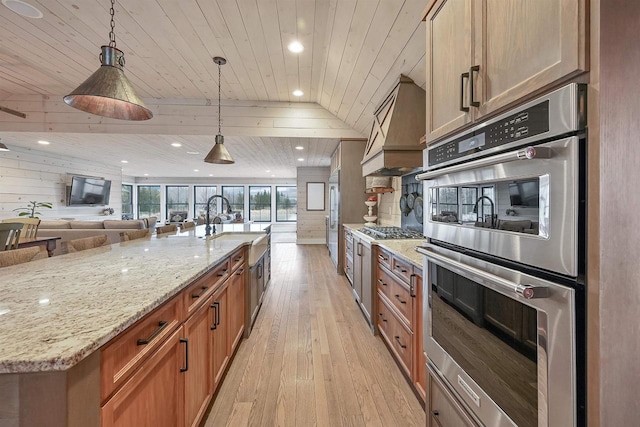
[424,136,580,277]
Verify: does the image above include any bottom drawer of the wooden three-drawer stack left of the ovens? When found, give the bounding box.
[377,296,413,378]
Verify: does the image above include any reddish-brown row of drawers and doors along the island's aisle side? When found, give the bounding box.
[100,248,247,427]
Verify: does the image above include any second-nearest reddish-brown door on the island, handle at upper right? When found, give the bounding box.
[184,298,213,427]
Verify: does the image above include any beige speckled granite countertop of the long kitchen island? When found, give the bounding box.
[0,224,268,373]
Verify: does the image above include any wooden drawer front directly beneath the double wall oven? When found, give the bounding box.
[427,369,478,427]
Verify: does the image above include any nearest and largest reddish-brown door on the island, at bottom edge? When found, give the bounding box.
[101,328,188,427]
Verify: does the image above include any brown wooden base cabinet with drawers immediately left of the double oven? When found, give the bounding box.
[374,246,427,400]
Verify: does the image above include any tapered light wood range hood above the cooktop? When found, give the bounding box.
[360,75,426,176]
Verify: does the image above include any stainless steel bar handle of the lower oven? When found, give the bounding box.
[416,243,549,299]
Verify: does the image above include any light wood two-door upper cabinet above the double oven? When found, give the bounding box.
[424,0,587,142]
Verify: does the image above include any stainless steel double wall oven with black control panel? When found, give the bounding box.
[417,84,586,427]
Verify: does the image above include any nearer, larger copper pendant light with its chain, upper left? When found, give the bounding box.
[64,0,153,120]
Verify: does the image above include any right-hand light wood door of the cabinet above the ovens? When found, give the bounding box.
[473,0,587,115]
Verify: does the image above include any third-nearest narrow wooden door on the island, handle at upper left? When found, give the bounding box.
[209,284,229,389]
